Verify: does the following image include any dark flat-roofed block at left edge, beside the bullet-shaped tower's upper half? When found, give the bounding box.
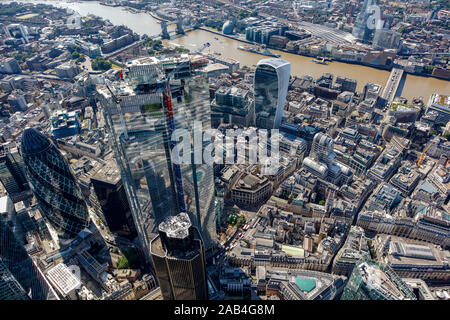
[0,144,30,195]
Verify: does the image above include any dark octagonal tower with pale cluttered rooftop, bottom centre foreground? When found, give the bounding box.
[151,212,208,300]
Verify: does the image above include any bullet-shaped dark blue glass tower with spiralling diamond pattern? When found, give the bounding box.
[21,128,89,239]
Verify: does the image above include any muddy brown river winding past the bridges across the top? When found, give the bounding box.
[11,0,450,103]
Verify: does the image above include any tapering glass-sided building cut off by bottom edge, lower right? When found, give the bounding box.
[341,260,416,300]
